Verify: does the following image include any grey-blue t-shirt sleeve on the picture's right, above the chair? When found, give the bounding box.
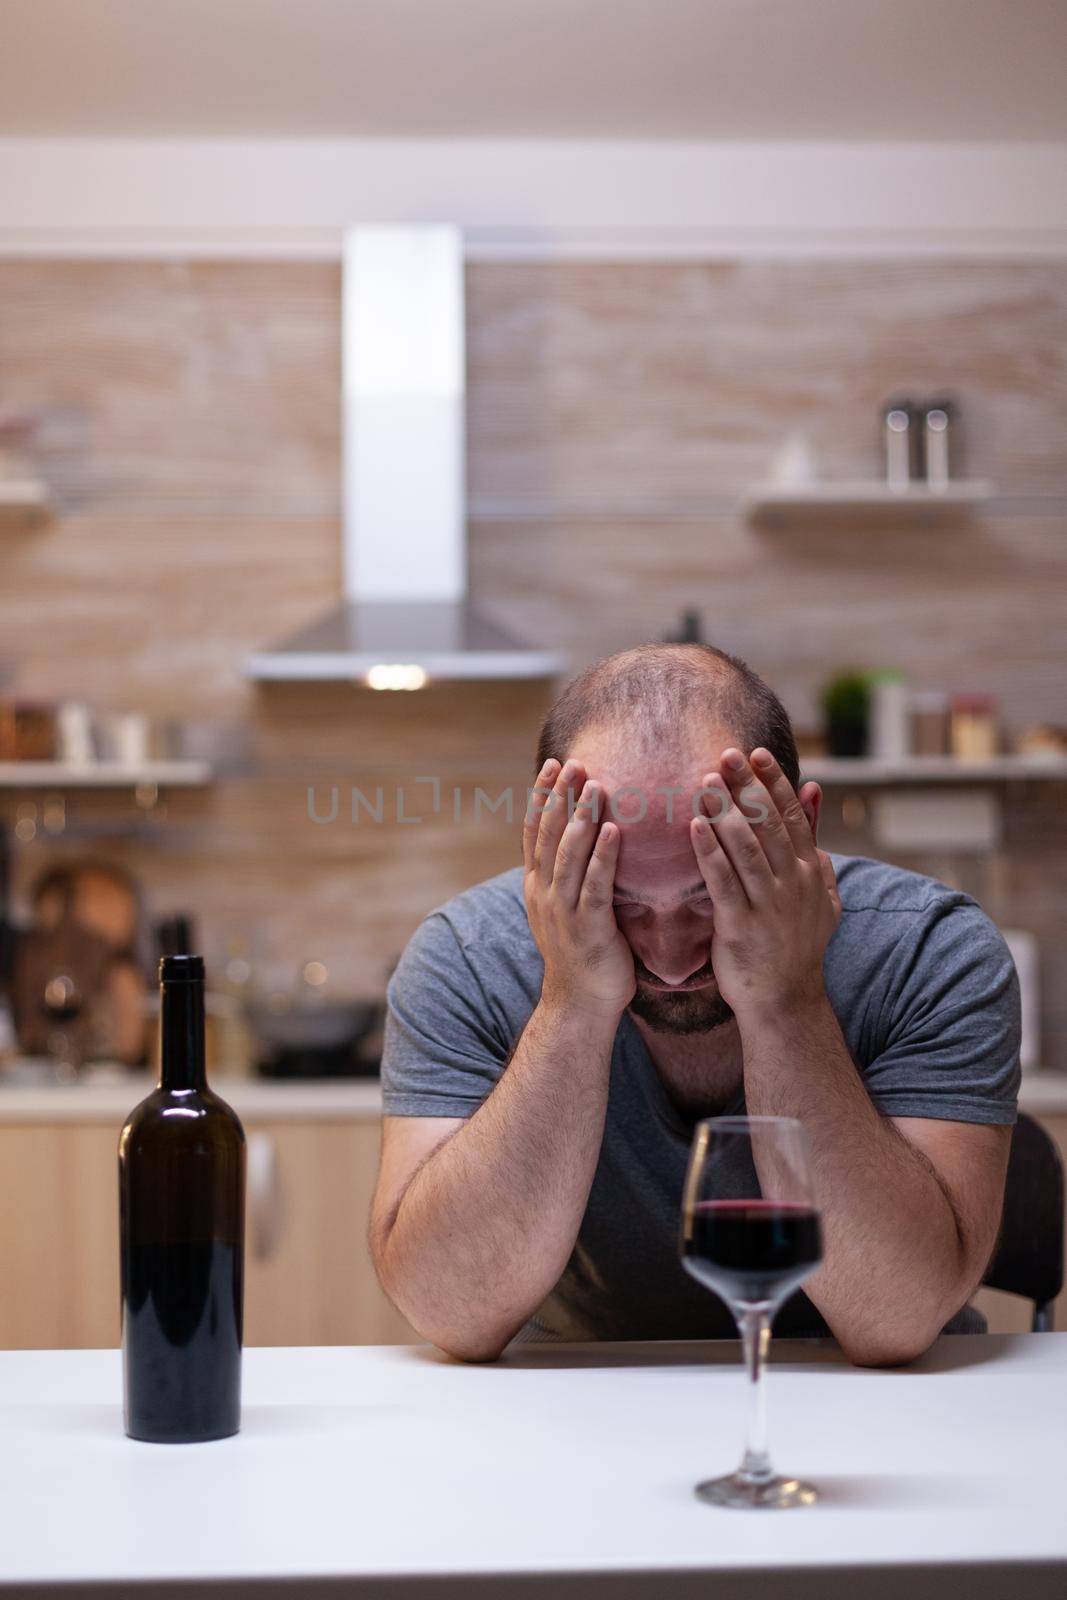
[865,899,1021,1123]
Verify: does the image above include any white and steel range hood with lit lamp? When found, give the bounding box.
[246,226,566,688]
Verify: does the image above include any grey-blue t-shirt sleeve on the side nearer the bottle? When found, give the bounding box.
[381,912,509,1117]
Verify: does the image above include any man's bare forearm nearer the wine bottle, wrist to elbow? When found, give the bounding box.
[376,1002,617,1360]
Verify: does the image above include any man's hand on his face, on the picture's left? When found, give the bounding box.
[523,760,637,1018]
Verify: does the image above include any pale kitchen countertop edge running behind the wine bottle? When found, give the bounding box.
[0,1072,1067,1128]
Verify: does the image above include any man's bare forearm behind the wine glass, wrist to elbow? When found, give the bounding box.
[737,994,971,1362]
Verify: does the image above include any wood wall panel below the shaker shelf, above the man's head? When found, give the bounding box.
[472,501,1067,728]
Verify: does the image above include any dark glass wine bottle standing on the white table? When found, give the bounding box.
[118,955,245,1445]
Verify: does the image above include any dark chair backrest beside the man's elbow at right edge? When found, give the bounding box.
[984,1112,1064,1326]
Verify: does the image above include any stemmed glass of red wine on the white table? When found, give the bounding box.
[681,1117,822,1509]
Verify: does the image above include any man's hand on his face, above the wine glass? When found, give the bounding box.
[689,747,841,1021]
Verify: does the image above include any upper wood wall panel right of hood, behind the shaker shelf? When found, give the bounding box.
[467,261,1067,502]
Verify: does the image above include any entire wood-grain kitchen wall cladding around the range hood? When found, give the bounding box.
[0,261,1067,1066]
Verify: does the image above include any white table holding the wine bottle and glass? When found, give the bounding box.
[0,1333,1067,1600]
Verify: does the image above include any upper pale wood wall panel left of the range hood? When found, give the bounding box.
[0,261,341,512]
